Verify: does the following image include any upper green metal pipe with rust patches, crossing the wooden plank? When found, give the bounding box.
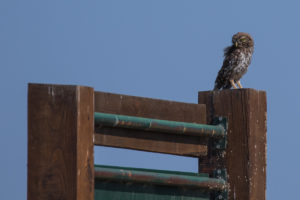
[94,112,226,137]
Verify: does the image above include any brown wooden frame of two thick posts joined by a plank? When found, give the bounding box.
[27,84,266,200]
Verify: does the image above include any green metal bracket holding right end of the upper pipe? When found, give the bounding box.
[212,117,228,150]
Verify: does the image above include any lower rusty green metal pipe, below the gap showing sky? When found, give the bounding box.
[95,166,227,190]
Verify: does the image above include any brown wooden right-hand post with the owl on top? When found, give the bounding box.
[198,89,267,200]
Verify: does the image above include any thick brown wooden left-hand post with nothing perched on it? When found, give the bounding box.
[27,84,94,200]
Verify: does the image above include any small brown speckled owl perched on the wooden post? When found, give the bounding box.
[214,32,254,90]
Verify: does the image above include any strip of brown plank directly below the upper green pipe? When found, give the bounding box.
[94,127,207,157]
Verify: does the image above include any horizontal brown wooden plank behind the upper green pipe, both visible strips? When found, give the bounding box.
[94,92,207,157]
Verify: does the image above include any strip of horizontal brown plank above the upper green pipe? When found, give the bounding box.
[95,92,206,124]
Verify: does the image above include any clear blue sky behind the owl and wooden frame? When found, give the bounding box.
[0,0,300,200]
